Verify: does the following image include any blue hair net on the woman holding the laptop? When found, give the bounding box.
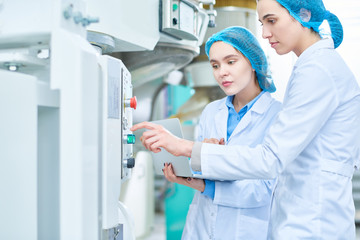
[205,27,276,92]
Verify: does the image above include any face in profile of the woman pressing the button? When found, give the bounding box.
[257,0,305,56]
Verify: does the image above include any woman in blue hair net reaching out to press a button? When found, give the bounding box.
[133,0,360,240]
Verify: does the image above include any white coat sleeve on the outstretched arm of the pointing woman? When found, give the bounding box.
[201,64,339,180]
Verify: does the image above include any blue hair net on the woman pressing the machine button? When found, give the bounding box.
[276,0,344,48]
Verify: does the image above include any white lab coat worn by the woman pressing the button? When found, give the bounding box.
[201,39,360,240]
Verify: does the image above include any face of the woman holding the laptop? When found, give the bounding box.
[209,41,258,96]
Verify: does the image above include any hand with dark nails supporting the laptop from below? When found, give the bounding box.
[163,163,205,192]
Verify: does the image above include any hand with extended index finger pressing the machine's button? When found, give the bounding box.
[130,122,194,157]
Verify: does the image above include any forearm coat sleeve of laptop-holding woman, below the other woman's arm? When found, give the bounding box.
[214,179,276,208]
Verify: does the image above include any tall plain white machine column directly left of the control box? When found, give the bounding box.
[51,30,101,240]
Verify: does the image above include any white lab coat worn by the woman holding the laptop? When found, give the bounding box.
[182,92,281,240]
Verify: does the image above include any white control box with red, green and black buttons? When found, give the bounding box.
[99,55,137,232]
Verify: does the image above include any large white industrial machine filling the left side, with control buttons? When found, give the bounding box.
[0,0,211,240]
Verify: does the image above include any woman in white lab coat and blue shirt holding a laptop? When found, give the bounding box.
[164,27,281,240]
